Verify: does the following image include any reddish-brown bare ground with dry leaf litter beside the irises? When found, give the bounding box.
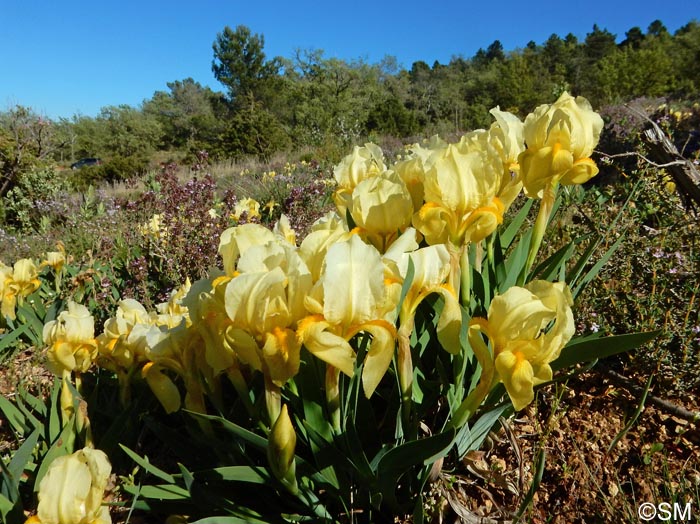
[430,373,700,524]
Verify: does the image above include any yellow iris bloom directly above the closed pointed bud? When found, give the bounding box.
[176,217,312,422]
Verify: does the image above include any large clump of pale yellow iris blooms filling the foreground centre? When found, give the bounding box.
[31,93,602,506]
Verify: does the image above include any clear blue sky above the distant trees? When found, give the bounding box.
[0,0,700,119]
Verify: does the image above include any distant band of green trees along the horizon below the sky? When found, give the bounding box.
[0,17,700,194]
